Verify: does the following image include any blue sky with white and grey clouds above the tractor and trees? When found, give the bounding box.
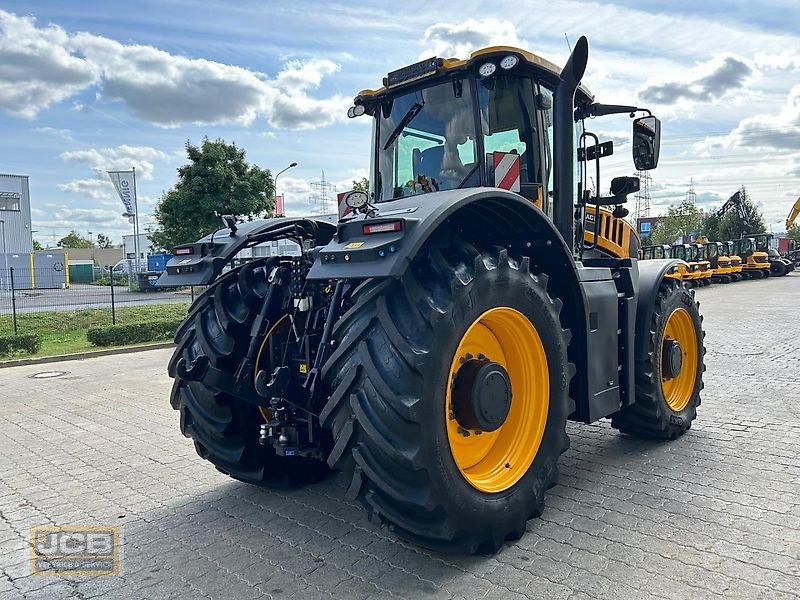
[0,0,800,243]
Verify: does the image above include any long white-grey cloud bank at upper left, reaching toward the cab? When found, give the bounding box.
[0,11,348,129]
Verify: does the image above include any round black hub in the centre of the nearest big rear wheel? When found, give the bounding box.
[453,358,511,431]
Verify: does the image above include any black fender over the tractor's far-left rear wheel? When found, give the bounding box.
[156,217,336,287]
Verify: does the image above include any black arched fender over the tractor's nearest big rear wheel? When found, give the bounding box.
[309,187,604,418]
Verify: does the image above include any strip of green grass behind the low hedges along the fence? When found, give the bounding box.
[0,302,189,356]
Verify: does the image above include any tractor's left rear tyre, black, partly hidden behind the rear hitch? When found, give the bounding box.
[168,259,328,486]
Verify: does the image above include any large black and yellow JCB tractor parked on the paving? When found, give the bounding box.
[159,38,705,553]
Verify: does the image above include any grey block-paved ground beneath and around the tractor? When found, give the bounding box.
[0,274,800,600]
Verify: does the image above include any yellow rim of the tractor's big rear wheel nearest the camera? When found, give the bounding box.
[444,307,550,493]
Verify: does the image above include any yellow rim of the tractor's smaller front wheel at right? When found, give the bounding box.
[659,308,699,412]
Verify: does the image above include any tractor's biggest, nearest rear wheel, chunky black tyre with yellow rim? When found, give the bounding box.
[321,243,574,554]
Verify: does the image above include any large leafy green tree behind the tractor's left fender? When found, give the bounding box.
[149,138,275,250]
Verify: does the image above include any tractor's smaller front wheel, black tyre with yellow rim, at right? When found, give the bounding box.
[611,279,706,440]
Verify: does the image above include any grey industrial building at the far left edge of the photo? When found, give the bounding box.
[0,175,33,254]
